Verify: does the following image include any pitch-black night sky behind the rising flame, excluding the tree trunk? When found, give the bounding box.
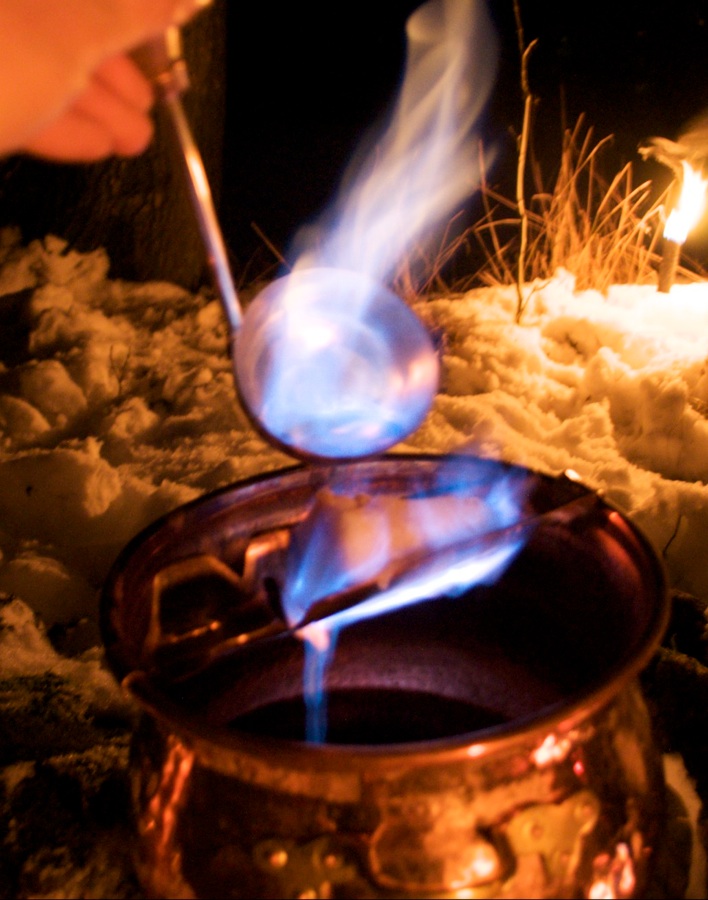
[222,0,708,276]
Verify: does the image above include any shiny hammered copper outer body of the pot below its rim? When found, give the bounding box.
[132,683,663,898]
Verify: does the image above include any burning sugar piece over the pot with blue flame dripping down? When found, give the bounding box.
[281,472,529,743]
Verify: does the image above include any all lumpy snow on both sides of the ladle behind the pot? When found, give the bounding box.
[0,230,708,640]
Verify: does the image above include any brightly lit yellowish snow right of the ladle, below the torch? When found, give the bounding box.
[410,272,708,597]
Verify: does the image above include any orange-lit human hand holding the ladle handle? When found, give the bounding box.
[0,0,211,162]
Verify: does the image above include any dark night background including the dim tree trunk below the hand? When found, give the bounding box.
[0,0,708,286]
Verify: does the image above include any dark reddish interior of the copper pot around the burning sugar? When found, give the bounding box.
[104,457,665,744]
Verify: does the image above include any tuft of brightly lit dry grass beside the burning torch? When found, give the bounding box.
[469,117,704,318]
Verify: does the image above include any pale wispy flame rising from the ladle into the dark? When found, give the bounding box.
[296,0,497,284]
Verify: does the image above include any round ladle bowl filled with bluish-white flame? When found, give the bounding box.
[236,268,439,459]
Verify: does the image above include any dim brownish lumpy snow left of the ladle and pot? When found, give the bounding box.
[0,231,291,626]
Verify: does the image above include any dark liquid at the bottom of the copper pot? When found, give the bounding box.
[229,688,507,745]
